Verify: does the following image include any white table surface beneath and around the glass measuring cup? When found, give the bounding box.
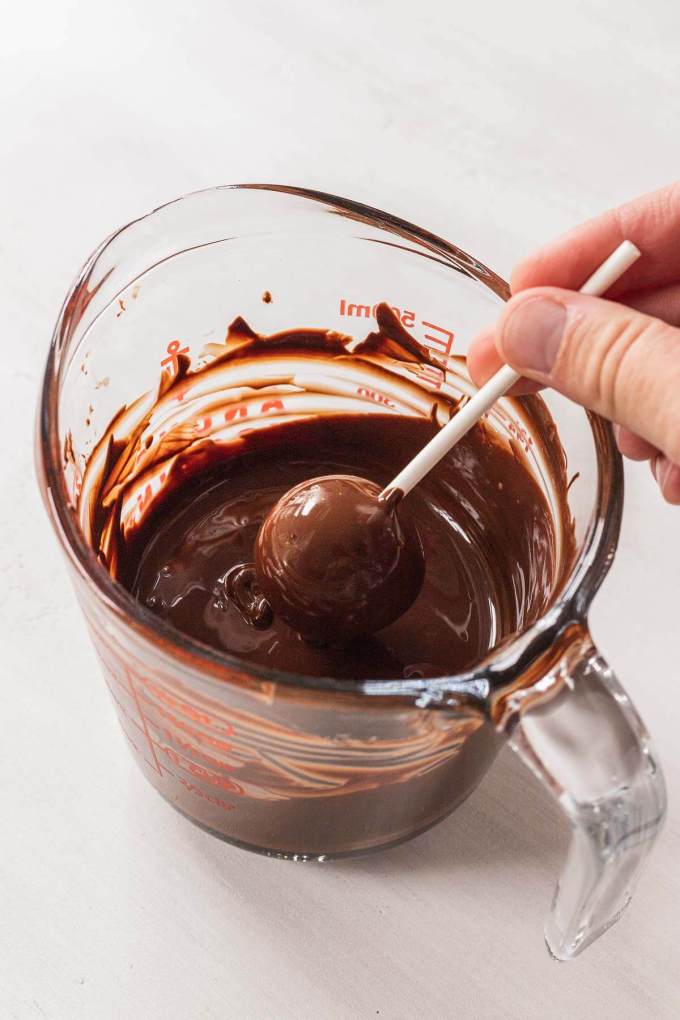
[0,0,680,1020]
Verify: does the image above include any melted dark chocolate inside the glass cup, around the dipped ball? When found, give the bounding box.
[79,306,574,679]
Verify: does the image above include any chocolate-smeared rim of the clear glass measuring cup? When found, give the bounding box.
[37,184,623,706]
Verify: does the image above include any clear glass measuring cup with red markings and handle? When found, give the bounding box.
[38,186,665,959]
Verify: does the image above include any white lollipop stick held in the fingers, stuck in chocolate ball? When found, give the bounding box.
[380,234,640,499]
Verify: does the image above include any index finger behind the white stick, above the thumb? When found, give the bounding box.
[511,181,680,298]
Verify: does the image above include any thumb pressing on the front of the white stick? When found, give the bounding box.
[495,287,680,464]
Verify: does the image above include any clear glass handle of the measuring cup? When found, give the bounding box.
[498,627,666,960]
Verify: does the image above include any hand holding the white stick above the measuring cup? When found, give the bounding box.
[468,181,680,504]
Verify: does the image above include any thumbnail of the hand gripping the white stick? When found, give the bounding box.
[501,298,567,375]
